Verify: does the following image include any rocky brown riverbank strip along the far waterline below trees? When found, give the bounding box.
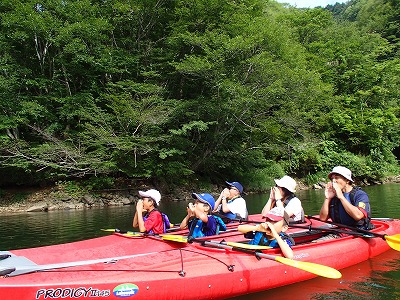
[0,175,400,215]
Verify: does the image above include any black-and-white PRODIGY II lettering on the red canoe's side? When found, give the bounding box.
[36,287,111,299]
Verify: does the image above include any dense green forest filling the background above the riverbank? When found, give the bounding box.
[0,0,400,190]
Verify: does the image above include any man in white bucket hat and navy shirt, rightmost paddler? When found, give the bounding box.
[319,166,374,230]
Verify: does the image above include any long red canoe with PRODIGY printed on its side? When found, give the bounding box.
[0,215,400,300]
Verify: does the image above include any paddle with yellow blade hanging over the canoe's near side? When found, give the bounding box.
[202,241,342,279]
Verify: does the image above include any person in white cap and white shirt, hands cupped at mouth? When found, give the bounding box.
[261,175,304,223]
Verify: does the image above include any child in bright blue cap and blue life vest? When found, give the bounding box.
[180,193,226,238]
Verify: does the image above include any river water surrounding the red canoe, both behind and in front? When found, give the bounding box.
[0,184,400,300]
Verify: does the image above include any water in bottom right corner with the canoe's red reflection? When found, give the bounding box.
[231,250,400,300]
